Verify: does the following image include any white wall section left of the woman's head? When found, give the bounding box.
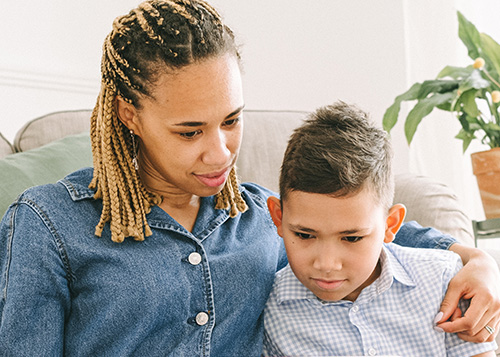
[0,0,138,140]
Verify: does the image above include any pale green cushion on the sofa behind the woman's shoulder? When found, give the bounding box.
[0,132,92,217]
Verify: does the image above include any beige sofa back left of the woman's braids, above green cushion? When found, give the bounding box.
[14,109,92,152]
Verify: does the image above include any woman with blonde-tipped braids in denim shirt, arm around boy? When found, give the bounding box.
[0,0,499,356]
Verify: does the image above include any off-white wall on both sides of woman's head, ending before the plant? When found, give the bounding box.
[0,0,407,172]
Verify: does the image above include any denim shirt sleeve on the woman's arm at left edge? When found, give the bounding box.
[0,203,70,356]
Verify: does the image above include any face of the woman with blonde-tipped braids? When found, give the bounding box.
[120,55,244,196]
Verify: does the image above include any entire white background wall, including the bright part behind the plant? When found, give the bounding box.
[0,0,500,216]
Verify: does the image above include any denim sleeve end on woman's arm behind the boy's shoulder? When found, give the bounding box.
[394,221,457,249]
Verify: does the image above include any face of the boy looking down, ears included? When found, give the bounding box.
[268,189,404,301]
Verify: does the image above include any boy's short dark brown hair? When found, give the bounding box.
[280,102,394,209]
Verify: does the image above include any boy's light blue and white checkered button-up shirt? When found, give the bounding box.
[264,243,497,357]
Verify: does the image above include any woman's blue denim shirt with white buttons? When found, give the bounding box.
[0,169,455,356]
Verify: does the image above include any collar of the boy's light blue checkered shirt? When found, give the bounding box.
[275,244,415,304]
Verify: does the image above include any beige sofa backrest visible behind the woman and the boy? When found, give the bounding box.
[7,110,474,245]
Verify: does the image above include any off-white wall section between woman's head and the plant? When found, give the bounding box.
[213,0,408,171]
